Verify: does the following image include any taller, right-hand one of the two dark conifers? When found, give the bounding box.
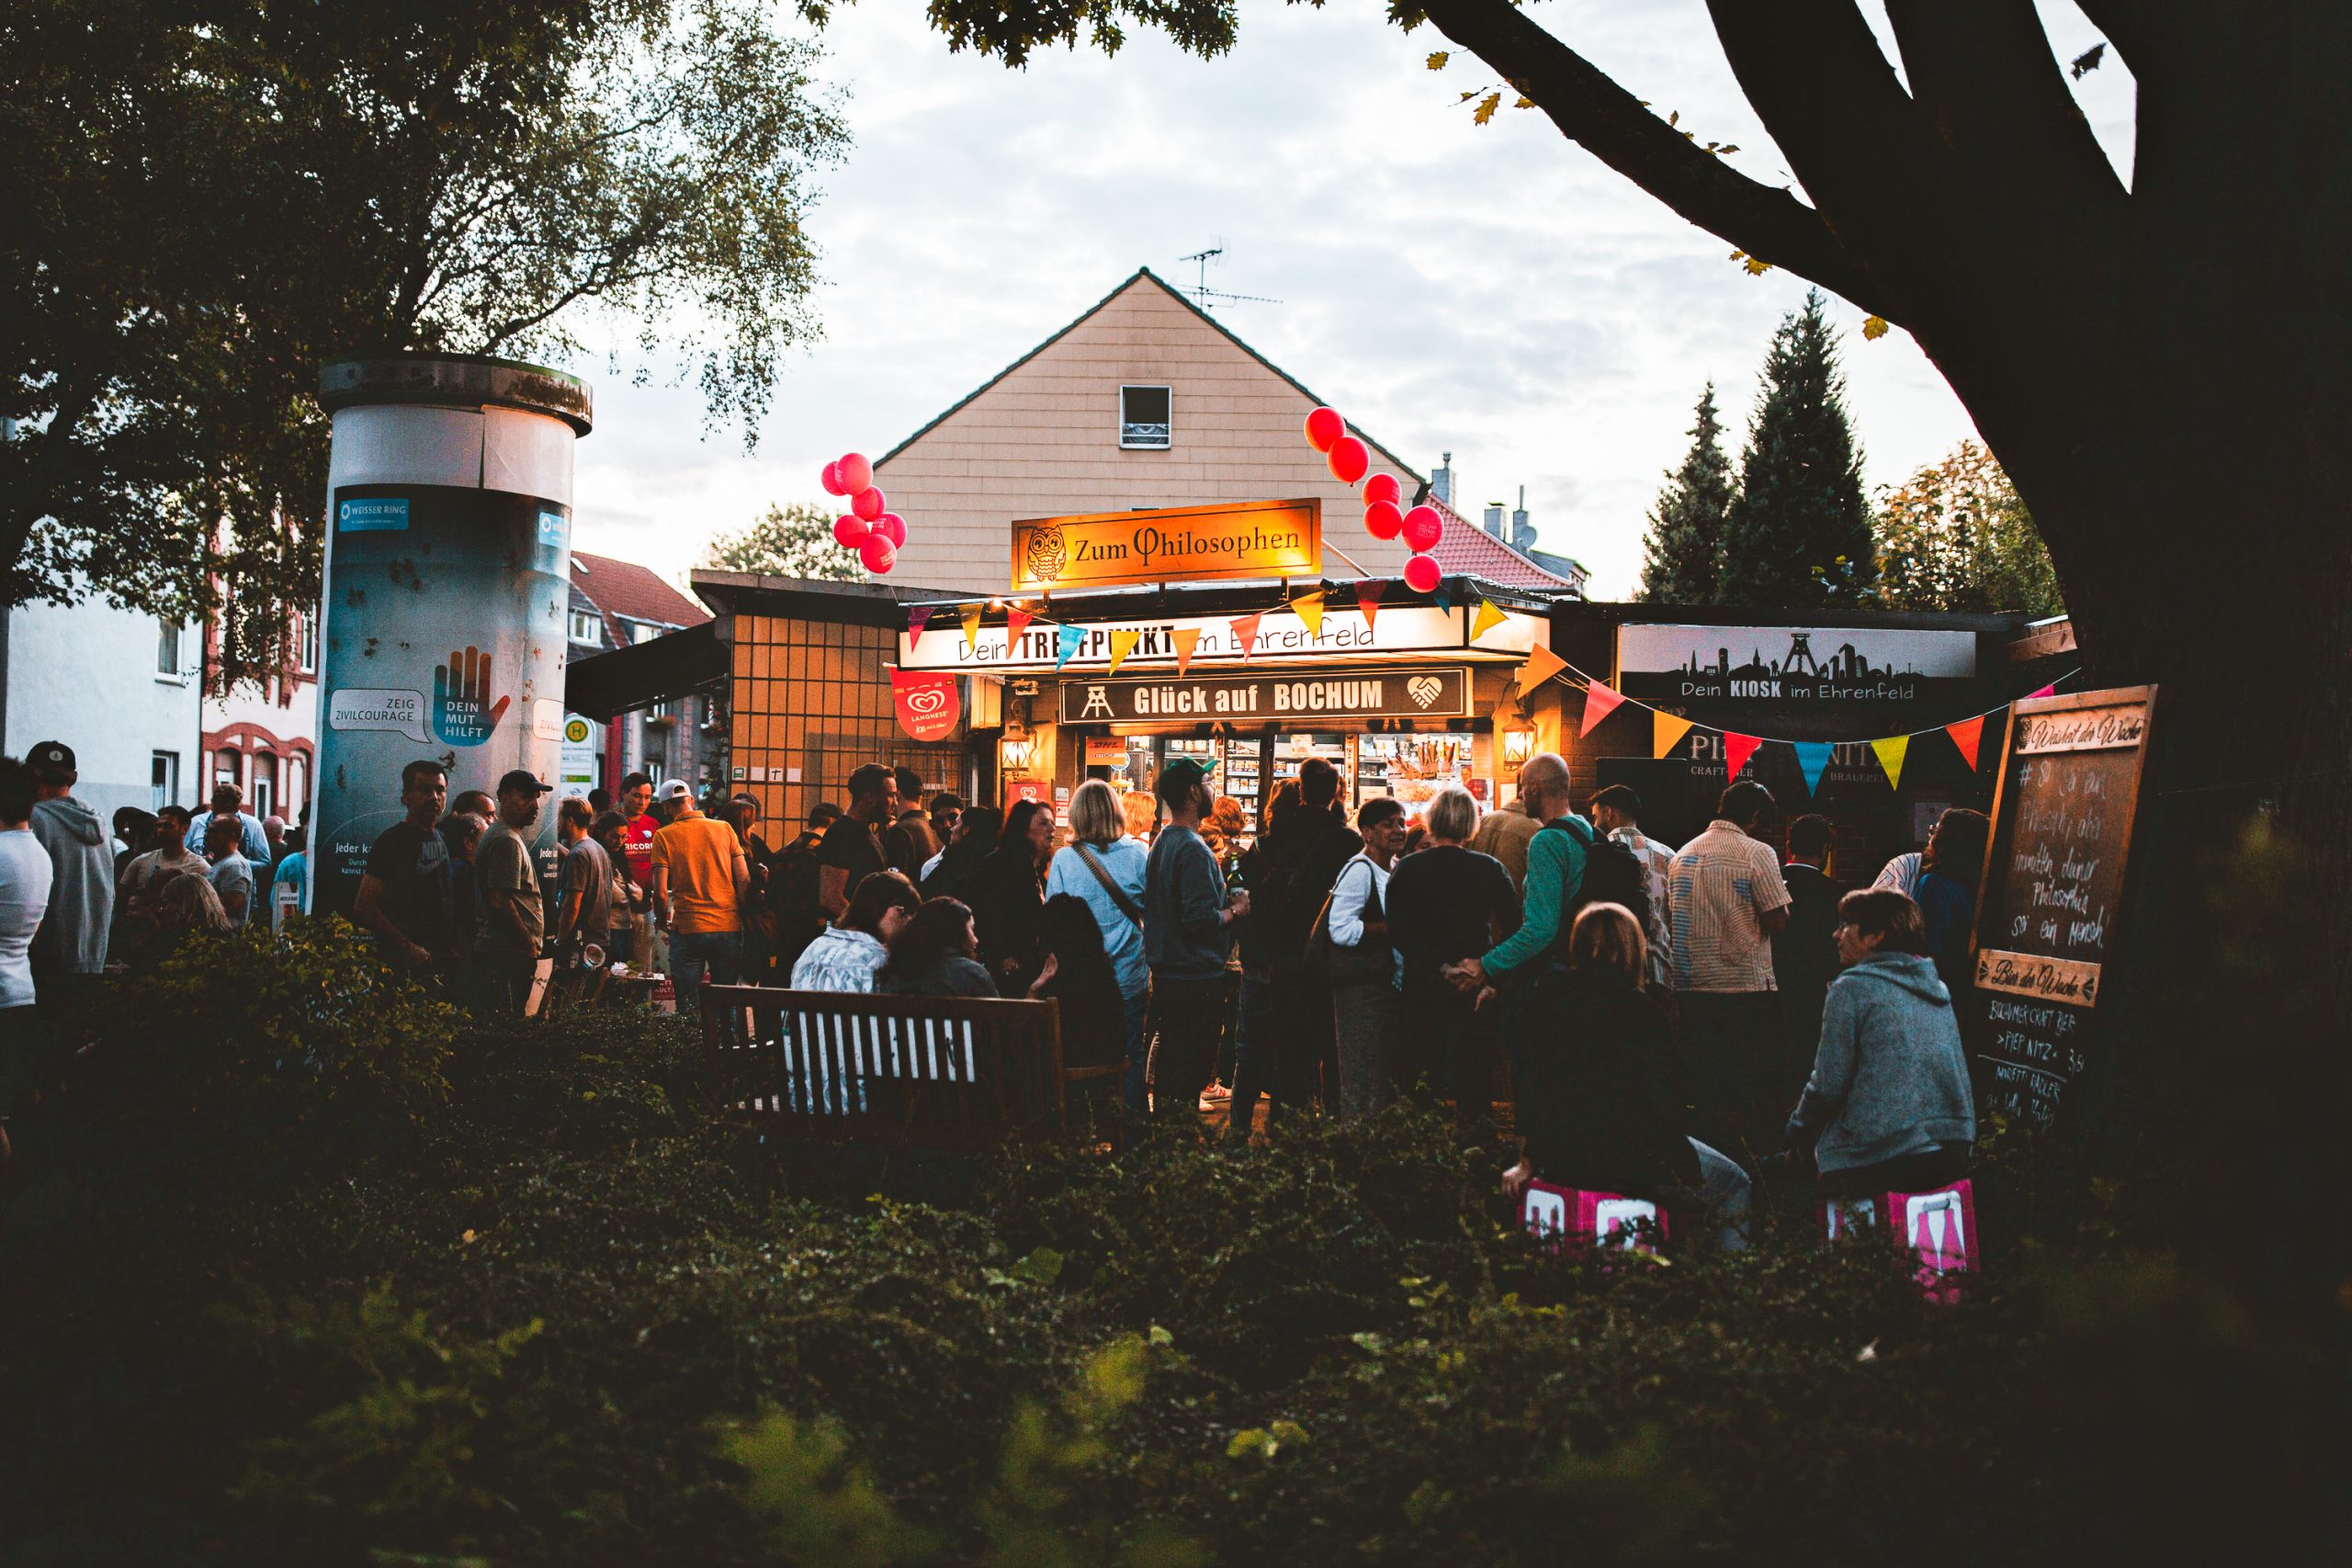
[1717,289,1877,609]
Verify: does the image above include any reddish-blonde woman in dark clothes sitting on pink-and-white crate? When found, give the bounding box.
[1503,903,1747,1248]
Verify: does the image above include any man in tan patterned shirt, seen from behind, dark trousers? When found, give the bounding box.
[1665,781,1802,1156]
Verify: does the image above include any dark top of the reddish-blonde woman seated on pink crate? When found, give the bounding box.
[1517,968,1698,1197]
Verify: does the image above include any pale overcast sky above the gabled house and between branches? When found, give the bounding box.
[576,0,2133,597]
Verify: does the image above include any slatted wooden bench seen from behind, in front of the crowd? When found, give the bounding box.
[703,985,1125,1149]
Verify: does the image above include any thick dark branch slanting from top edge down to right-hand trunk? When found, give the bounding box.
[1423,0,1900,322]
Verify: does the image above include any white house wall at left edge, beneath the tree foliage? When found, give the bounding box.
[0,602,205,816]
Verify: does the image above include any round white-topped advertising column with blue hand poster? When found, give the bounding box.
[311,357,591,915]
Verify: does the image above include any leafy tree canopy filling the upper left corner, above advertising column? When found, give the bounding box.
[0,0,844,677]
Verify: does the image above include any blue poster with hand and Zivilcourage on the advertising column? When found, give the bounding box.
[311,484,571,915]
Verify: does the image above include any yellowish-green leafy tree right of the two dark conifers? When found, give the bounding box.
[1877,442,2065,616]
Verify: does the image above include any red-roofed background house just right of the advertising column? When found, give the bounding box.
[567,550,727,790]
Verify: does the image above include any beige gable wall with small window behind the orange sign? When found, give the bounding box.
[875,277,1416,592]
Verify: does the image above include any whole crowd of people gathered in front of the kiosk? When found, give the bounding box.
[0,743,1990,1223]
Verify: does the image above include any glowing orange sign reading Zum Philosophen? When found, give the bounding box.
[1013,501,1322,592]
